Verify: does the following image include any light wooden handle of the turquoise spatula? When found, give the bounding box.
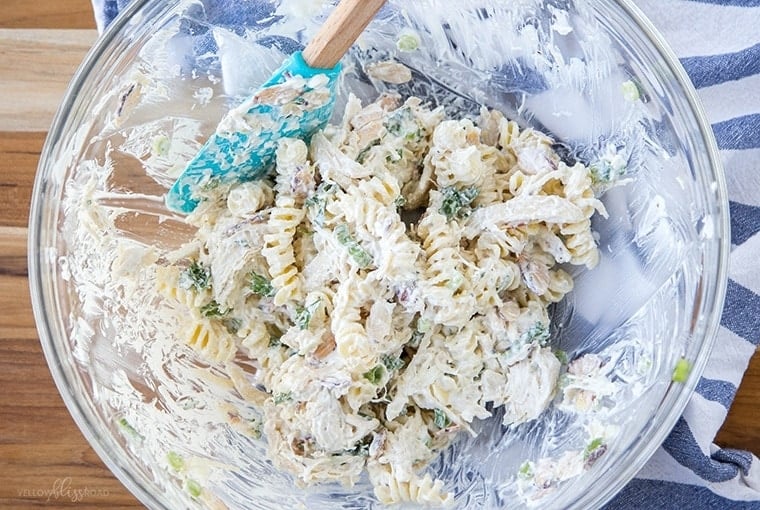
[303,0,385,69]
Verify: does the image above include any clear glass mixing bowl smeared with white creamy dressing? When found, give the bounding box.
[29,0,729,509]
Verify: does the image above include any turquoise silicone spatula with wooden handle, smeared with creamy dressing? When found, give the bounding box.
[166,0,385,214]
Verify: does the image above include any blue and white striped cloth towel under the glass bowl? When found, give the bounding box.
[92,0,760,510]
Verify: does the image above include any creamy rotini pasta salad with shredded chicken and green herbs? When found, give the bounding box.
[158,89,606,505]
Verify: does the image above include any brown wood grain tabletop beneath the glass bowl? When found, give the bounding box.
[0,0,760,509]
